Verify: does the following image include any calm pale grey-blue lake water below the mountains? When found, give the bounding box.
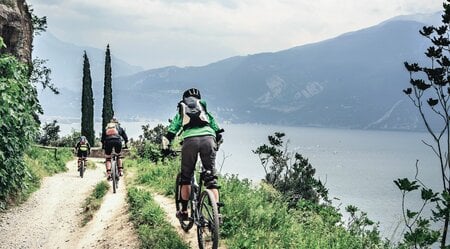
[60,122,439,238]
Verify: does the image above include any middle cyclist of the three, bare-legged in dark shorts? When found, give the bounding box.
[101,117,128,180]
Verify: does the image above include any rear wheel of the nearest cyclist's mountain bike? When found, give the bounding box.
[197,189,220,249]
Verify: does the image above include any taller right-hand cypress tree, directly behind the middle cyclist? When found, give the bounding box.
[102,44,114,138]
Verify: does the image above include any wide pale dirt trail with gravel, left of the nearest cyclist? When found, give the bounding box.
[0,161,139,249]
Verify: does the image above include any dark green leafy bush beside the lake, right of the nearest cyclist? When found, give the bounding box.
[253,132,328,206]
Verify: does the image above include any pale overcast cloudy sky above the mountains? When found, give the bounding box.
[27,0,443,69]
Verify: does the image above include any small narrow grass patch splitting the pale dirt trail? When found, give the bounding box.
[81,181,110,226]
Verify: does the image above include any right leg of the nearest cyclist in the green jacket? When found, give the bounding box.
[199,136,219,202]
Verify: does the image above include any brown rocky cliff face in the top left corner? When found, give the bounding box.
[0,0,33,64]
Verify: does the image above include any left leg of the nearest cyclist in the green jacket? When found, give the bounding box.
[181,137,198,211]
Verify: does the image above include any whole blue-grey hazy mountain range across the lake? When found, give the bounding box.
[35,13,440,130]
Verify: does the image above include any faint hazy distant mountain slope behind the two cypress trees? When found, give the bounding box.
[33,32,143,117]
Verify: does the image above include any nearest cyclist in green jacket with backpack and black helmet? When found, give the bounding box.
[162,88,222,220]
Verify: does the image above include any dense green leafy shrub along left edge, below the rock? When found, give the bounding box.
[0,50,40,208]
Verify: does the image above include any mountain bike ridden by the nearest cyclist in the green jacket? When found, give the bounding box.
[175,163,220,249]
